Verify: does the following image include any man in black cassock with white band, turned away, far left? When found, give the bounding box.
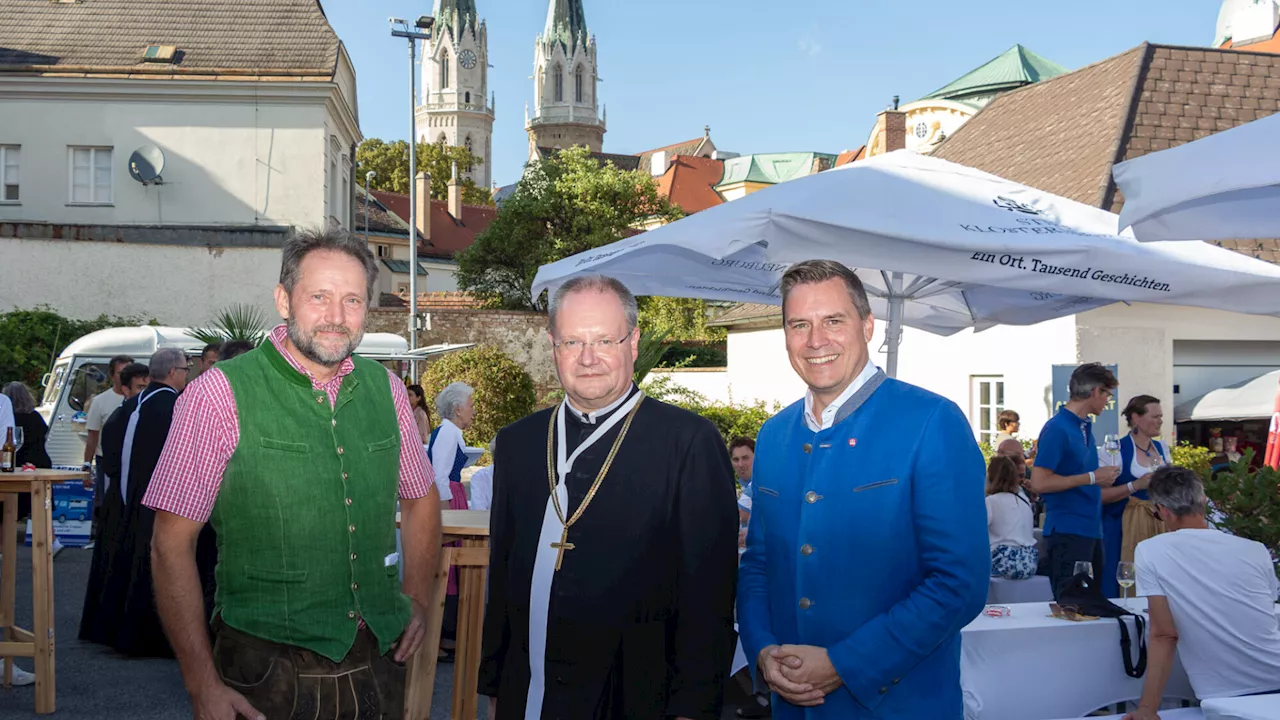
[79,347,216,657]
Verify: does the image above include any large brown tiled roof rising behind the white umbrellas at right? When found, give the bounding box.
[934,44,1280,261]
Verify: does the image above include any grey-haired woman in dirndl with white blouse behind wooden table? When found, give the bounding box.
[426,383,476,662]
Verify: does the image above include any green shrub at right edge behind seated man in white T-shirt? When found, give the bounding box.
[1204,448,1280,574]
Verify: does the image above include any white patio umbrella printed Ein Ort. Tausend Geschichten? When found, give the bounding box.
[532,151,1280,375]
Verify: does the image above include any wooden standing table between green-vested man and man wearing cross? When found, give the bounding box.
[396,510,489,720]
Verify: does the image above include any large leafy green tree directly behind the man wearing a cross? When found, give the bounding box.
[457,147,684,310]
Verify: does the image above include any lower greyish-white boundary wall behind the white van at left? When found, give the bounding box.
[0,237,280,327]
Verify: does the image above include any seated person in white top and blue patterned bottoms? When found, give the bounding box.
[987,455,1039,580]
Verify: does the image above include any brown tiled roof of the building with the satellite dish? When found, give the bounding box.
[0,0,339,74]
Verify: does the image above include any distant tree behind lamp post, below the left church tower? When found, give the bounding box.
[356,137,493,205]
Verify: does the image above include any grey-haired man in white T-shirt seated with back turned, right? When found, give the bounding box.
[1125,466,1280,720]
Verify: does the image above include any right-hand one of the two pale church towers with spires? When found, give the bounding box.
[525,0,605,160]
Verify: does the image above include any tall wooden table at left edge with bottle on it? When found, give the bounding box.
[0,470,88,715]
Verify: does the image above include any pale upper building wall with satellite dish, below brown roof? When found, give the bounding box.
[0,90,337,225]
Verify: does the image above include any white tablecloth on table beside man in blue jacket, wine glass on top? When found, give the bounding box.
[960,598,1196,720]
